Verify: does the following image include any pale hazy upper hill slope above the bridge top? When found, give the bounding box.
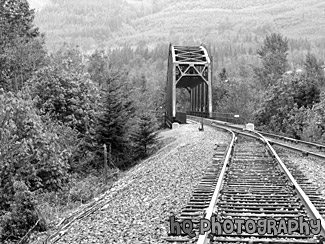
[30,0,325,53]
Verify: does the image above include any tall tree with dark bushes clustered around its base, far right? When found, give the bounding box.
[255,34,325,140]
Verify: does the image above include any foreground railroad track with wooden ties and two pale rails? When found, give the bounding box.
[166,121,325,244]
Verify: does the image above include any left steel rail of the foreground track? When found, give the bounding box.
[197,127,236,244]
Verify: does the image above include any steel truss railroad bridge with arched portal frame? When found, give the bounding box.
[166,44,212,126]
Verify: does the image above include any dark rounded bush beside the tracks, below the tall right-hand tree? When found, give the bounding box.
[255,71,320,138]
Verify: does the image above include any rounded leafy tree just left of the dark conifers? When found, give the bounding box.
[26,66,100,135]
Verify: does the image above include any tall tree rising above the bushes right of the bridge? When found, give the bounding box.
[254,33,289,89]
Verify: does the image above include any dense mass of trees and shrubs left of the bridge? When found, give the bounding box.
[0,0,163,243]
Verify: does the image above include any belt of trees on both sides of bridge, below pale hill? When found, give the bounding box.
[0,0,325,243]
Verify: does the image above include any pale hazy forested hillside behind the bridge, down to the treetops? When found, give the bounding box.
[30,0,325,83]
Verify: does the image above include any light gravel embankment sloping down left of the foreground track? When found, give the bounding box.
[45,124,230,244]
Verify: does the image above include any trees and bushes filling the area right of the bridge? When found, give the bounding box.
[213,33,325,143]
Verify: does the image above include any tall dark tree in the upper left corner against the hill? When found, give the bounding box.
[0,0,46,91]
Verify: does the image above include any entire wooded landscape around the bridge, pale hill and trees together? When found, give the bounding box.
[0,0,325,244]
